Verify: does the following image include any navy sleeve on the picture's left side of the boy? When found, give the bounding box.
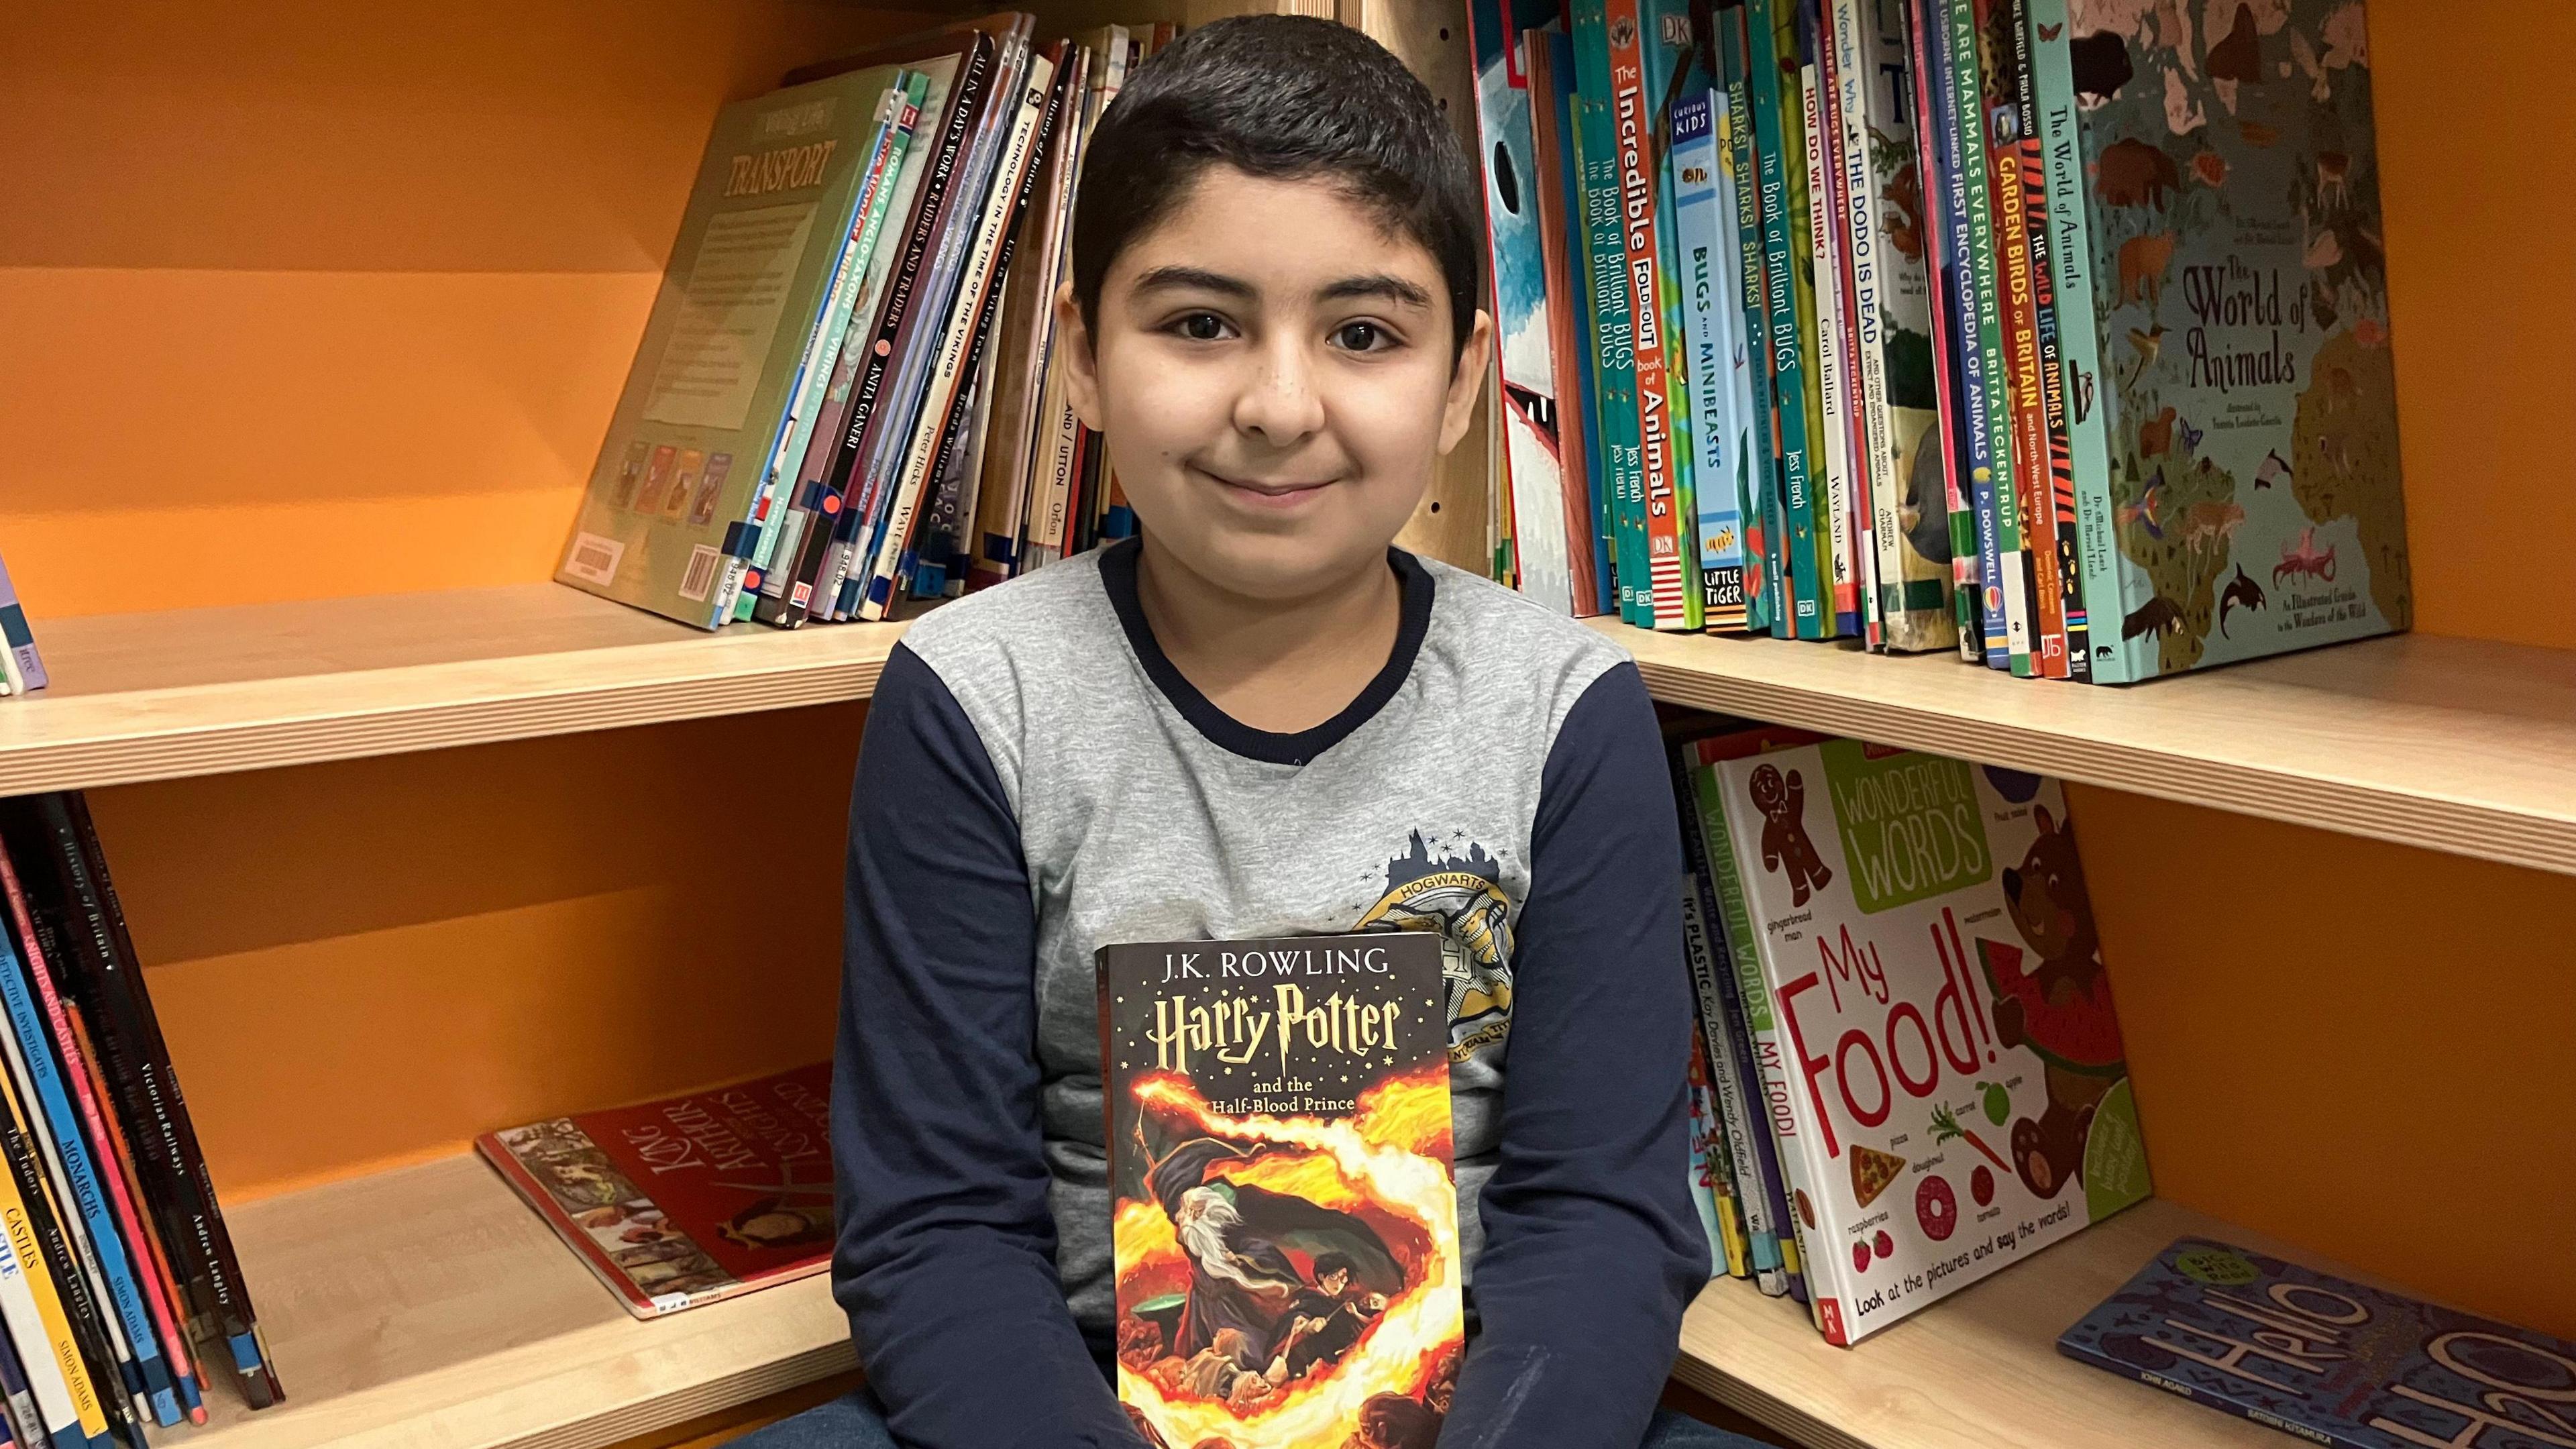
[832,647,1136,1449]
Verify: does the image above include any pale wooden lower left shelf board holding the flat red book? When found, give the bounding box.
[171,1155,858,1449]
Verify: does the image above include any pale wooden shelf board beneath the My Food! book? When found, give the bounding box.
[1672,1199,2367,1449]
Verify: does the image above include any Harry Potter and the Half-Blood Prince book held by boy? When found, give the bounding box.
[1097,930,1466,1449]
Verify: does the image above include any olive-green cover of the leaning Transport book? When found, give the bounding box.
[556,72,906,629]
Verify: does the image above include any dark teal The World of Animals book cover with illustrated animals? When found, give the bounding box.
[2069,0,2414,678]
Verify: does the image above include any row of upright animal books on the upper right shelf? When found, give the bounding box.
[1468,0,2411,681]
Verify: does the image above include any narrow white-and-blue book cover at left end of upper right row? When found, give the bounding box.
[1466,0,1574,614]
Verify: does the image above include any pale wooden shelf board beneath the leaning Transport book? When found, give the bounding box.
[0,583,904,794]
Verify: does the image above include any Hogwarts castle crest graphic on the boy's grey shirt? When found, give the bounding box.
[1352,830,1512,1065]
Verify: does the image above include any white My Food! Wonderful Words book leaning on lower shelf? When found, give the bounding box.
[1718,740,2149,1343]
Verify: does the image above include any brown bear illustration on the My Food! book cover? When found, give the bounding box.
[1978,804,2128,1199]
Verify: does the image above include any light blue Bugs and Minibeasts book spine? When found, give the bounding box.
[1672,85,1744,634]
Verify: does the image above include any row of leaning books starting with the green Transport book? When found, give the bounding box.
[556,13,1175,629]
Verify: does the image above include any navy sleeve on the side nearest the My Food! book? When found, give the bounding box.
[1440,665,1708,1449]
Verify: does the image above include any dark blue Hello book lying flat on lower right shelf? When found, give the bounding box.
[2058,1238,2576,1449]
